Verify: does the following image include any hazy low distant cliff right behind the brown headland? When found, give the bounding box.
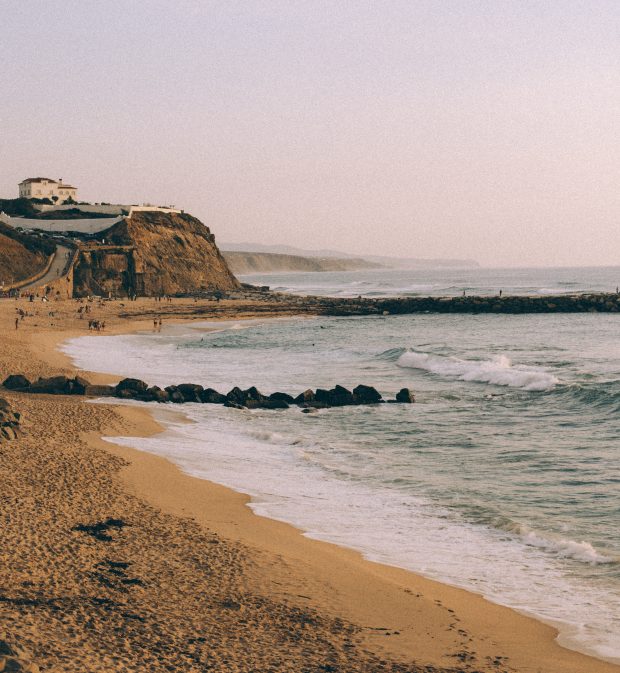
[222,251,381,274]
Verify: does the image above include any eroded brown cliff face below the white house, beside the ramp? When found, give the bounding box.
[74,212,239,297]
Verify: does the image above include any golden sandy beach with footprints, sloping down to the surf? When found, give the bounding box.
[0,300,620,673]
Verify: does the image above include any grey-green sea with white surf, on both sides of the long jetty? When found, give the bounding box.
[64,267,620,662]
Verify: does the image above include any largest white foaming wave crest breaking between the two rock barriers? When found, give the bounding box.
[396,351,559,392]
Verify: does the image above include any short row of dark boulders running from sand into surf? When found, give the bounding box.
[3,374,415,409]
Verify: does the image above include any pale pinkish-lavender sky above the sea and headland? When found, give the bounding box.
[0,0,620,266]
